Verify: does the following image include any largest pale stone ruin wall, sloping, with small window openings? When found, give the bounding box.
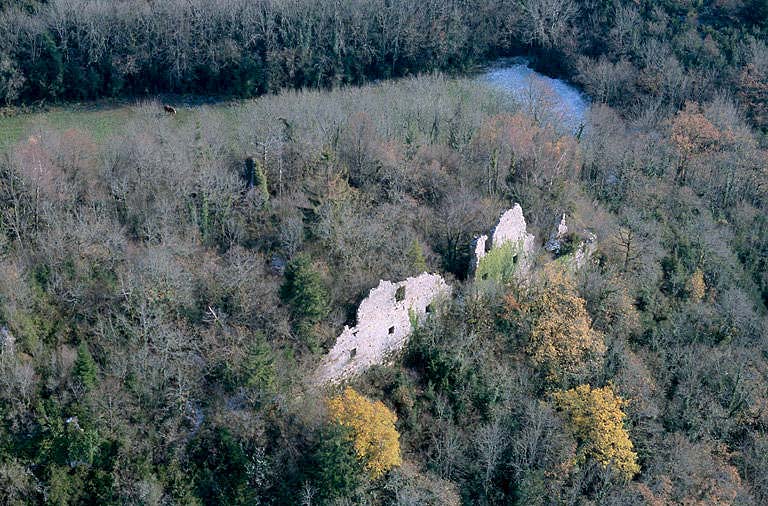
[317,272,451,383]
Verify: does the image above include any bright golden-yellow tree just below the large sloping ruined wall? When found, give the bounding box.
[328,387,402,479]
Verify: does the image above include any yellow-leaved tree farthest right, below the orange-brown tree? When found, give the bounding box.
[554,385,640,480]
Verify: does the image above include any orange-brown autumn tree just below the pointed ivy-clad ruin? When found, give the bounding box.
[522,265,605,386]
